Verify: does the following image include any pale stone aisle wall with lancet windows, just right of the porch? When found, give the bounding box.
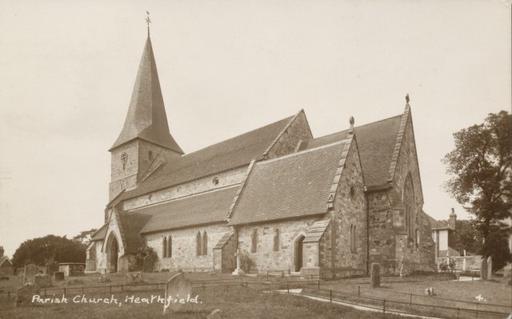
[144,224,232,271]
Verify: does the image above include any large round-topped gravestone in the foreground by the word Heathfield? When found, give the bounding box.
[164,272,192,314]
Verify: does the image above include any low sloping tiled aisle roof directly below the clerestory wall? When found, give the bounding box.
[137,186,238,233]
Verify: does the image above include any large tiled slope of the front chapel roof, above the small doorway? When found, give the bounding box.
[230,140,350,225]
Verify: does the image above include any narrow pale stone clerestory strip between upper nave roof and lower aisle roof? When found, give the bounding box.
[123,166,247,210]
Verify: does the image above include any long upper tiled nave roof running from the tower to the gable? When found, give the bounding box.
[117,116,293,199]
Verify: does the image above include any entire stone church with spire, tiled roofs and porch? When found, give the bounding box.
[86,35,434,278]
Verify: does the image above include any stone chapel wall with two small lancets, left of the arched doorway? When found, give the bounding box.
[237,218,316,272]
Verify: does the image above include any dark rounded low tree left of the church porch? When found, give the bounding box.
[12,235,86,267]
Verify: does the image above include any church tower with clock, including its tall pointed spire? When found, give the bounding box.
[109,30,183,200]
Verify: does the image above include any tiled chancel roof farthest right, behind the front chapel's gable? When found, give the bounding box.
[301,115,402,186]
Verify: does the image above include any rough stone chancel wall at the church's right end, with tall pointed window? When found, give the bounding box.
[368,111,435,274]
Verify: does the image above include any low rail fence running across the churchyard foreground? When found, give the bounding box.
[0,277,512,319]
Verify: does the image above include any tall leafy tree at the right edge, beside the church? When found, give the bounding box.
[444,111,512,268]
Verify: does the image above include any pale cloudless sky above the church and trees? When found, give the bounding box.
[0,0,511,256]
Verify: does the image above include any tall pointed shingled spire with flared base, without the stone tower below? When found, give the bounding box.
[110,33,183,154]
